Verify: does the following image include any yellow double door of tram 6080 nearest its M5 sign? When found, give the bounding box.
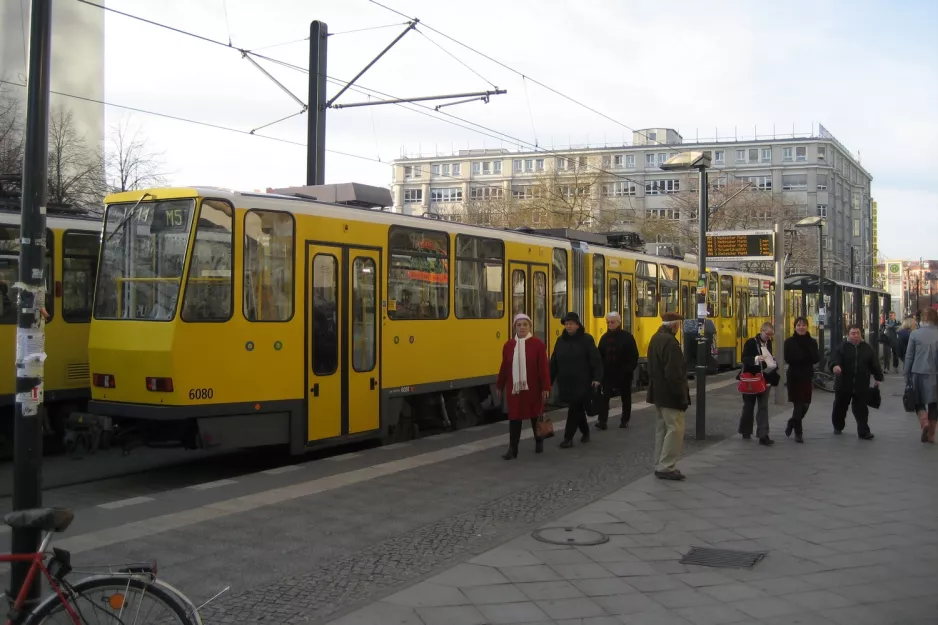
[306,245,381,441]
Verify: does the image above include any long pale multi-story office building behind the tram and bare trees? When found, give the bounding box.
[392,127,875,284]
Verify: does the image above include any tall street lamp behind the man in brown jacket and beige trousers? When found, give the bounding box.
[661,152,710,440]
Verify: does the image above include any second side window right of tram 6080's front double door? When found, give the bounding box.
[456,234,505,319]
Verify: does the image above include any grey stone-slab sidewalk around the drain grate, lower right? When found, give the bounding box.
[332,376,938,625]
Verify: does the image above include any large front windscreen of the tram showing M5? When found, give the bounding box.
[94,199,195,321]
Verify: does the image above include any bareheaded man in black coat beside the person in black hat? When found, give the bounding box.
[596,312,638,430]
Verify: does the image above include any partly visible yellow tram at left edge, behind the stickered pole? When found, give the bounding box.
[0,210,101,441]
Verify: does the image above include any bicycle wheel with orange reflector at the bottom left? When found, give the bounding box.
[26,575,196,625]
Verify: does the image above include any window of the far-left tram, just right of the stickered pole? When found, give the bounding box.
[62,231,101,323]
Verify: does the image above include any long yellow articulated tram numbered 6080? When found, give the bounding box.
[80,188,788,453]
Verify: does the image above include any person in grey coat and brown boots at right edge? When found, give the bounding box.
[903,308,938,443]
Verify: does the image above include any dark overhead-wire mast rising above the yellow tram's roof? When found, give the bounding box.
[306,20,329,186]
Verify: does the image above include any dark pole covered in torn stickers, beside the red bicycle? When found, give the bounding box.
[9,0,52,601]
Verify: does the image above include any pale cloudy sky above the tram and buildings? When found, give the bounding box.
[85,0,938,258]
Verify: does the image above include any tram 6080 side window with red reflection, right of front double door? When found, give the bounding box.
[388,227,449,319]
